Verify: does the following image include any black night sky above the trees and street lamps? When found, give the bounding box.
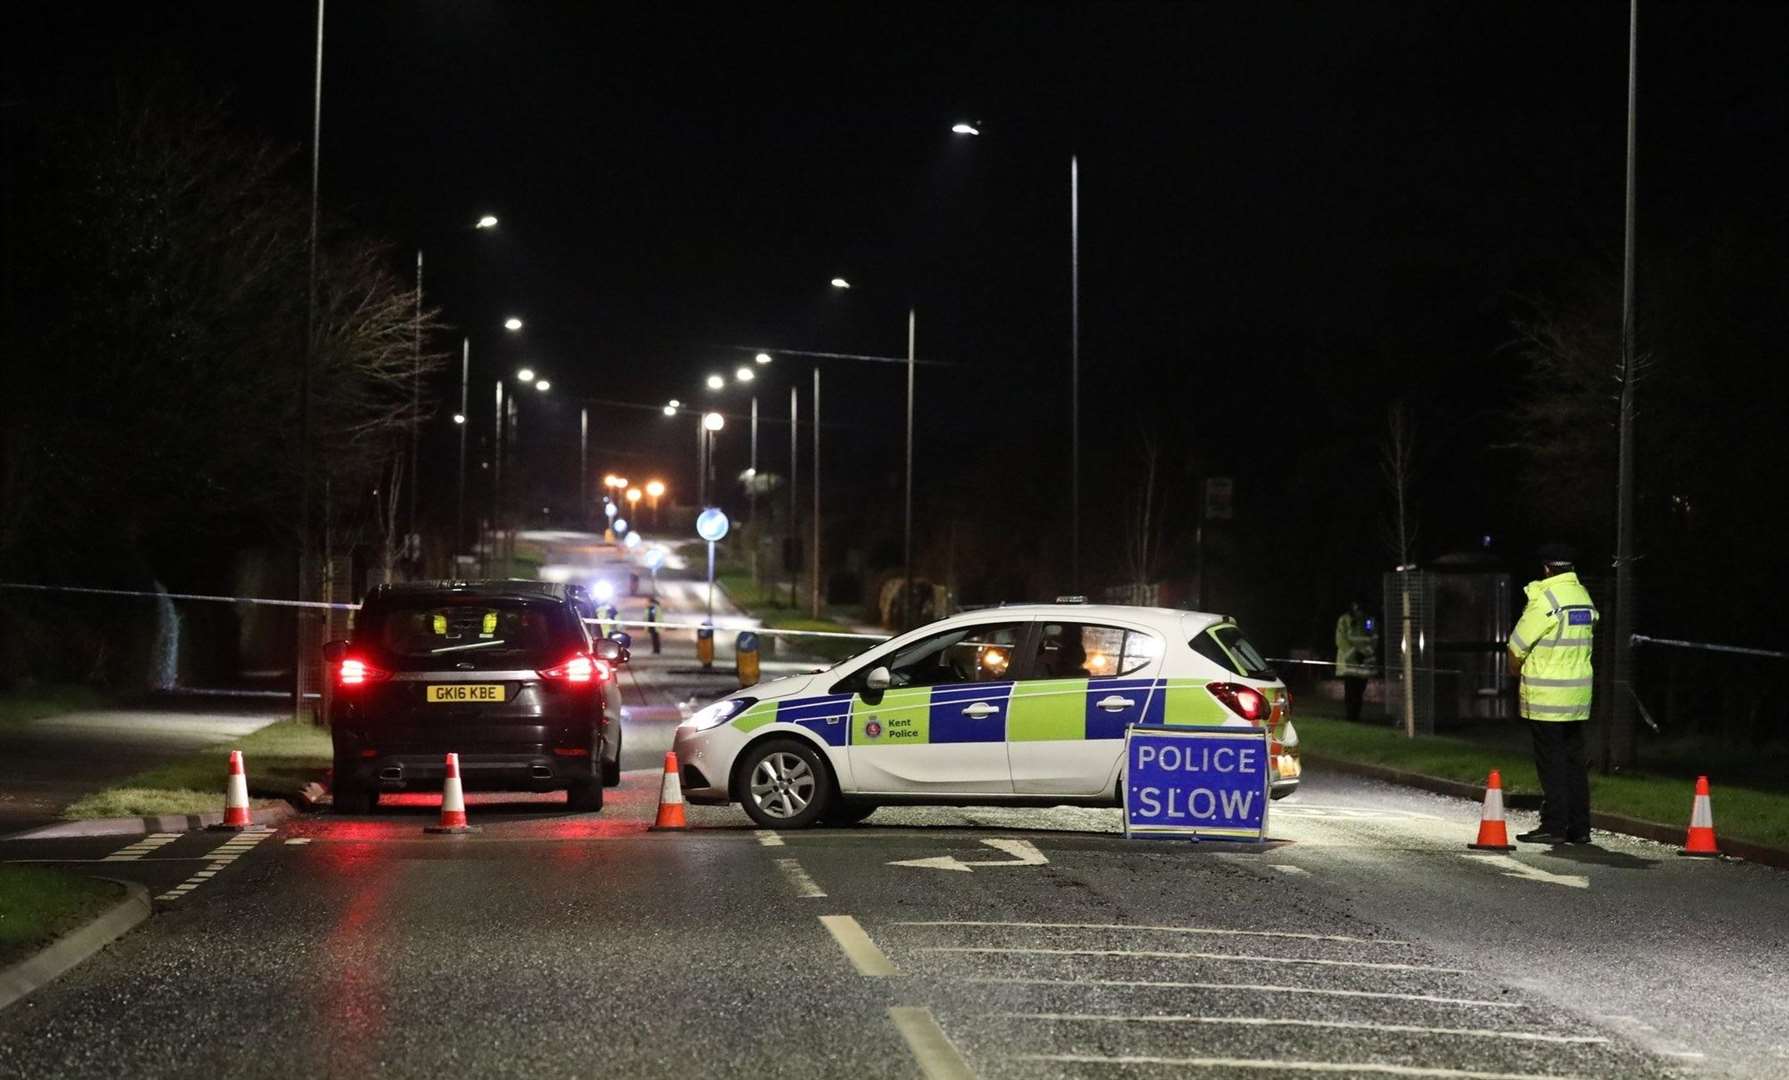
[5,0,1789,629]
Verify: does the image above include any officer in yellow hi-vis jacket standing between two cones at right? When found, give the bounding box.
[1510,544,1599,844]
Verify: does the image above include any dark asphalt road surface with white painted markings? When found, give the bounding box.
[0,536,1789,1078]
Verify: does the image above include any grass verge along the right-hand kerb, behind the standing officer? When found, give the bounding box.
[1295,713,1789,849]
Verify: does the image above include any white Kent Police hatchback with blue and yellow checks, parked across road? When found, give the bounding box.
[676,603,1299,828]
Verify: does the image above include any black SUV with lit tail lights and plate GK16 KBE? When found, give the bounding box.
[324,581,628,814]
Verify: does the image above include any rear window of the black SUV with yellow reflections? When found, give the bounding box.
[354,595,587,671]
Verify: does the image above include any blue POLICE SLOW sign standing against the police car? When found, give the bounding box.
[1123,728,1272,840]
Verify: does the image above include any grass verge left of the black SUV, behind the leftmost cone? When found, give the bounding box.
[63,721,331,819]
